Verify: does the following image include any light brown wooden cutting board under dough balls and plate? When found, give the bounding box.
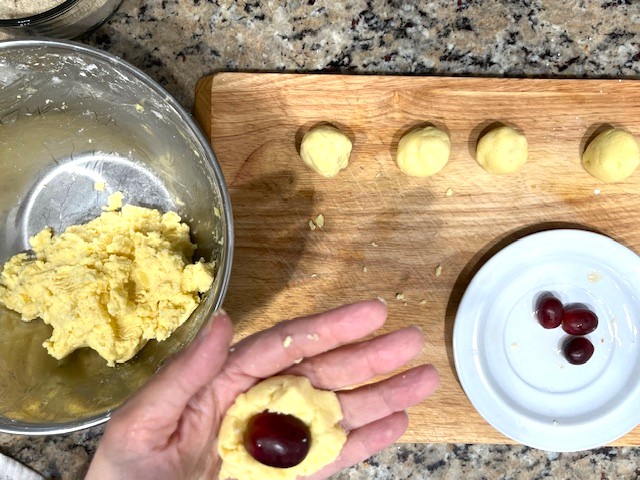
[195,73,640,445]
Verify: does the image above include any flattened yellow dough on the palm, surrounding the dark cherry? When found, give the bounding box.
[218,375,347,480]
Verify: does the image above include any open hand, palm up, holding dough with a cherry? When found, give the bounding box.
[86,300,438,480]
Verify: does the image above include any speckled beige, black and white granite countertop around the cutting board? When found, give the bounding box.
[0,0,640,480]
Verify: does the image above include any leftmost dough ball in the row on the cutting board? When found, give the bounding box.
[300,125,352,177]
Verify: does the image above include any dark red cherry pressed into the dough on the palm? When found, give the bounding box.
[244,411,311,468]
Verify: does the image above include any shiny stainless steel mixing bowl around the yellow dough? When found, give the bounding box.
[0,39,233,434]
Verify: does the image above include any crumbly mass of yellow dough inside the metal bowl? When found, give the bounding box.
[0,194,214,366]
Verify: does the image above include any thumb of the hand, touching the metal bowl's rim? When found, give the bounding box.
[116,310,233,436]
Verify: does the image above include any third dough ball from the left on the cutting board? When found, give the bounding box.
[476,126,528,175]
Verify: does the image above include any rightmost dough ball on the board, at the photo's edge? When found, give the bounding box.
[582,128,640,182]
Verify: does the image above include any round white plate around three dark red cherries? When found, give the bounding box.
[453,230,640,452]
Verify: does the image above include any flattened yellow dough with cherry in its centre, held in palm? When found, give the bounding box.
[218,375,347,480]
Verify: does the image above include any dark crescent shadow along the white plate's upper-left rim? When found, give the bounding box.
[444,222,603,384]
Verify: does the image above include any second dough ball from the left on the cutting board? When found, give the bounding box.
[396,127,451,177]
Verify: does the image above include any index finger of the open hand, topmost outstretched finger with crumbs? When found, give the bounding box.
[226,300,387,382]
